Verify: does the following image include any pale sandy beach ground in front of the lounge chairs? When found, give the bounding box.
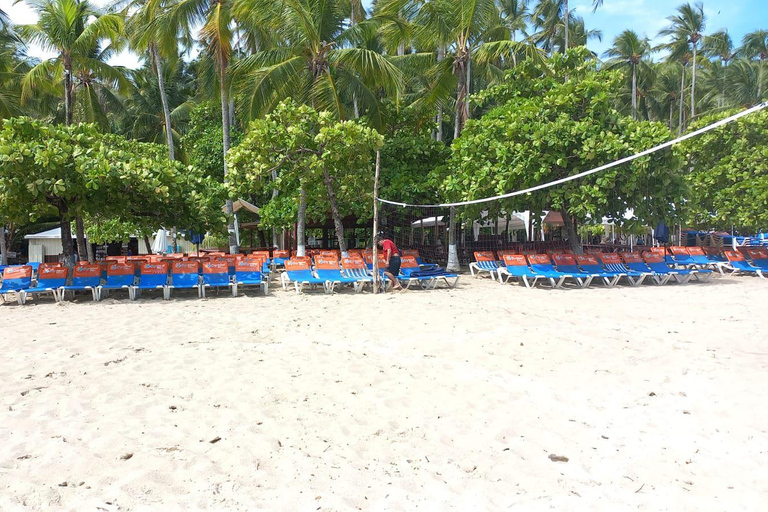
[0,276,768,512]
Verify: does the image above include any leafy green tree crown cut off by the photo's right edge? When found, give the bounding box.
[679,111,768,233]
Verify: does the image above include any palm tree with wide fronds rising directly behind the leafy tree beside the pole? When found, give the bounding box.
[234,0,404,254]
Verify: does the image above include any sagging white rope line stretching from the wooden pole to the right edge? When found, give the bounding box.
[379,102,768,208]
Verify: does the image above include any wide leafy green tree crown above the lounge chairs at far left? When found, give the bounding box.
[0,118,226,248]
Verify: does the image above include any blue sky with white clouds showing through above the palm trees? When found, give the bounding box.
[6,0,768,67]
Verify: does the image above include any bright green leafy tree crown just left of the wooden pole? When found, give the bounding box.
[228,100,383,227]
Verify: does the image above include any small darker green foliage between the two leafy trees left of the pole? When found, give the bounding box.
[181,104,243,181]
